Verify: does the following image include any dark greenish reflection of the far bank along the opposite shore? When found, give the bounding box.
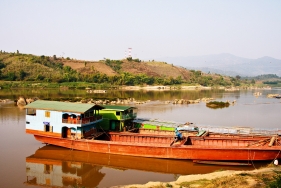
[0,88,225,101]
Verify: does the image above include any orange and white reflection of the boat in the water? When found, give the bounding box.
[25,145,264,187]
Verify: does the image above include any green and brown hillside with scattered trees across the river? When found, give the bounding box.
[0,51,239,86]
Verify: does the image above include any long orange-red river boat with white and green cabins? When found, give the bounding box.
[25,100,281,161]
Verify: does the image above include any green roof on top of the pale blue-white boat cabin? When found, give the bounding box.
[25,100,104,113]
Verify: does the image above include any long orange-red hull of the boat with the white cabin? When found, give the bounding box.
[34,135,281,161]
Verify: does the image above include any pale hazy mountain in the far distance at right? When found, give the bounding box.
[157,53,281,76]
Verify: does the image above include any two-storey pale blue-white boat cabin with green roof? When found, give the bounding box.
[25,100,104,139]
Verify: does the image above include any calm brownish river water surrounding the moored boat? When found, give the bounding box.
[0,89,281,188]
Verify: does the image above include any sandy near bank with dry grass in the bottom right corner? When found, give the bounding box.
[115,165,281,188]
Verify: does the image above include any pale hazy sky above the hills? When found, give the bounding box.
[0,0,281,60]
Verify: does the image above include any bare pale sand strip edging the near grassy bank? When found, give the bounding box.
[114,165,281,188]
